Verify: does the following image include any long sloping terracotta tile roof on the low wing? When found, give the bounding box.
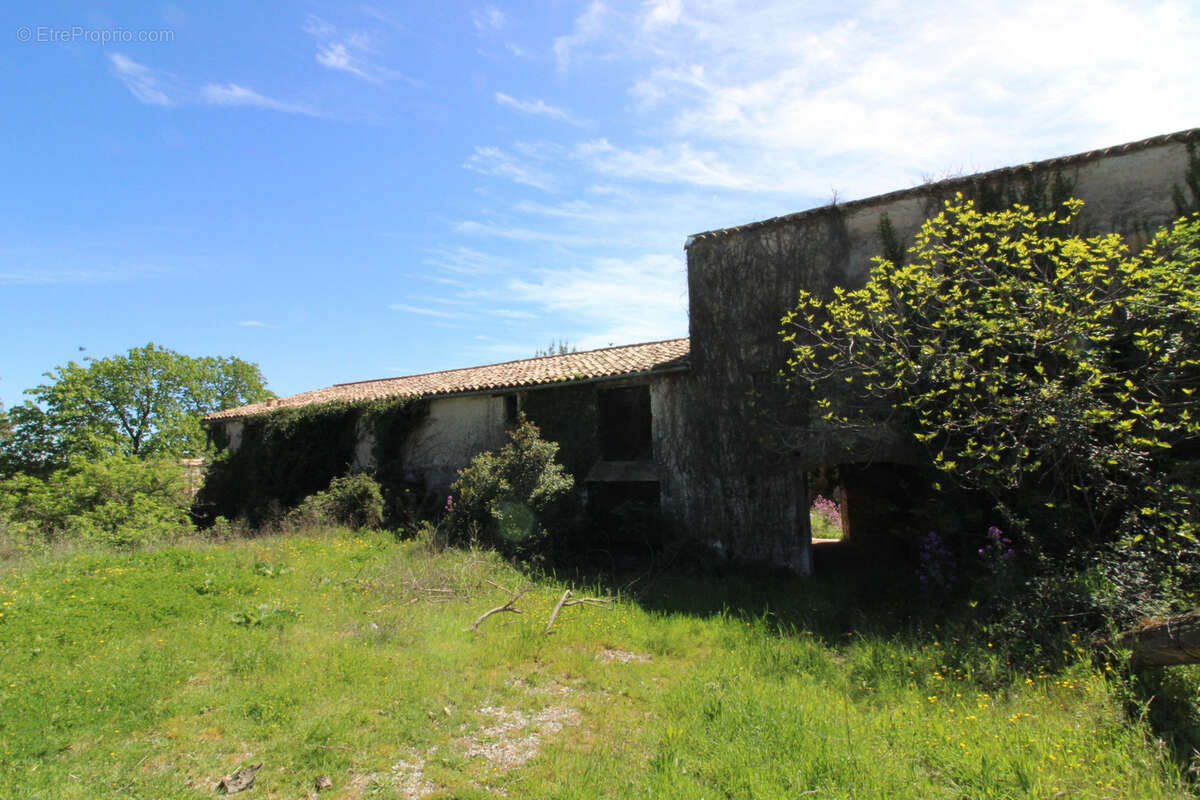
[204,338,689,422]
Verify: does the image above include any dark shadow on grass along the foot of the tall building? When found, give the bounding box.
[542,532,1200,782]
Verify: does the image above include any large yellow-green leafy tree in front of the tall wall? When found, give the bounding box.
[782,196,1200,559]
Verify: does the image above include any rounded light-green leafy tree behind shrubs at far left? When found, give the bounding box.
[0,342,270,474]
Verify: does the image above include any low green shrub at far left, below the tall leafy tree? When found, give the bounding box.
[0,456,192,547]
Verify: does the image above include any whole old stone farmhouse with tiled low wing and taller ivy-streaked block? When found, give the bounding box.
[204,128,1200,573]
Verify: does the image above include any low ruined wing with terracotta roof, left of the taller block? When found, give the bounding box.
[204,338,688,525]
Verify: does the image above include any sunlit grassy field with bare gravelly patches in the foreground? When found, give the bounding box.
[0,531,1188,799]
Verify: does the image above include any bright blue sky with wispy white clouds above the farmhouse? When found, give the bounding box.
[0,0,1200,404]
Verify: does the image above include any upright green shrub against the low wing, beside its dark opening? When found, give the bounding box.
[445,415,575,557]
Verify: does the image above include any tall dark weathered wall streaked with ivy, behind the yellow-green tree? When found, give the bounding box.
[686,130,1200,572]
